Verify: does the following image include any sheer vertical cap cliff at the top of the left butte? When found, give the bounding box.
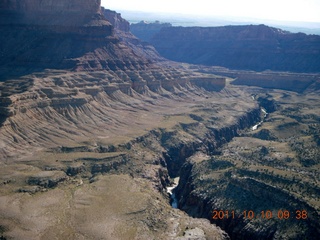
[0,0,101,26]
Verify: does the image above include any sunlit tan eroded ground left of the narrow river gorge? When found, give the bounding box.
[1,65,250,239]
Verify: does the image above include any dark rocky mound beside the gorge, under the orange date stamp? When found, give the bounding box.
[175,154,319,240]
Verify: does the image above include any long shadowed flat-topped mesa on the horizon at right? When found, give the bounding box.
[150,25,320,72]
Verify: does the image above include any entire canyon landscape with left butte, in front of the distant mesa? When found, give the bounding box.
[0,0,320,240]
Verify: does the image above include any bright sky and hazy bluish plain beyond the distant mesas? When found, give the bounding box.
[102,0,320,34]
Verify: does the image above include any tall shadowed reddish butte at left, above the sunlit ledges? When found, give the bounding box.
[0,0,159,80]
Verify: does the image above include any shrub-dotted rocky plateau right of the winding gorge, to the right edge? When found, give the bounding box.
[172,69,320,239]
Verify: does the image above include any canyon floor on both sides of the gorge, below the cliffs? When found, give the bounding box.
[0,62,320,239]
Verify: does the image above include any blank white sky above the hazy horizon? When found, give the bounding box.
[101,0,320,22]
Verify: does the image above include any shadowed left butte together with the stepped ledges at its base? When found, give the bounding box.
[0,1,225,154]
